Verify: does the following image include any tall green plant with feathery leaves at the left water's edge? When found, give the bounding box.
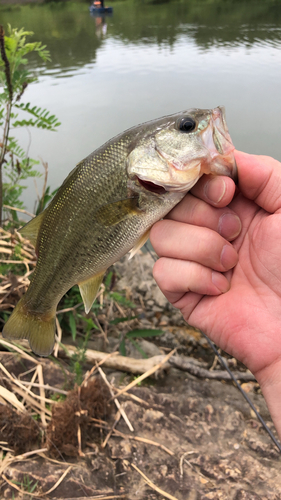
[0,25,60,225]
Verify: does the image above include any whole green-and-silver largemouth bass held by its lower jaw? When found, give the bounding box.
[2,106,237,356]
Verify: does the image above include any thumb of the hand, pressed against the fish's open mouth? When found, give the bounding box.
[235,151,281,213]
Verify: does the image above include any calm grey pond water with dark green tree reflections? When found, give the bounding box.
[0,0,281,210]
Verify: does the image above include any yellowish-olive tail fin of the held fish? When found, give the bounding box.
[2,297,56,356]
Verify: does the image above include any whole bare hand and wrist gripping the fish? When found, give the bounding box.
[150,151,281,438]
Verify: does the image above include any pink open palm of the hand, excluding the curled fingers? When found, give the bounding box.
[187,195,281,373]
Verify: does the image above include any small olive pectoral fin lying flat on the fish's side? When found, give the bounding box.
[95,197,141,227]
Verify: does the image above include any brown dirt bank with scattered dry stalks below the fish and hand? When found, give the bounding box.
[0,255,281,500]
